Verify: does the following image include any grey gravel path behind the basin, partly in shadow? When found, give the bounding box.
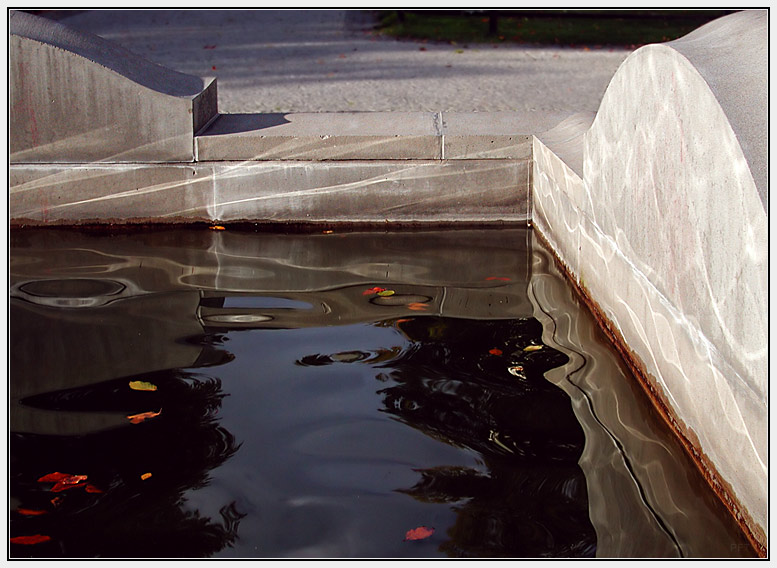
[61,10,629,113]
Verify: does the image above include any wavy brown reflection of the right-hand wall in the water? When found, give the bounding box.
[529,237,753,558]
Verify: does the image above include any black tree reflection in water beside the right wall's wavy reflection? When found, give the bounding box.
[297,317,596,557]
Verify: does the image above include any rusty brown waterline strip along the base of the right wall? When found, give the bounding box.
[533,227,768,558]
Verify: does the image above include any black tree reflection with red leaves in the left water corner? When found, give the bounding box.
[10,364,242,557]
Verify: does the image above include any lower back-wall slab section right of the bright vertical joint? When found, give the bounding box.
[213,160,529,223]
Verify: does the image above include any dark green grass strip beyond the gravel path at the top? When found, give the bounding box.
[376,10,731,47]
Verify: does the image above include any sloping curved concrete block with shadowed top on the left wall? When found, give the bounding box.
[9,11,217,163]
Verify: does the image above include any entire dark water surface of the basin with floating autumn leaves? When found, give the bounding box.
[9,228,751,558]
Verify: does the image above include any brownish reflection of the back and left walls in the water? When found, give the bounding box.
[10,228,531,433]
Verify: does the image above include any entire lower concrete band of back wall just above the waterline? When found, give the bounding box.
[9,160,529,225]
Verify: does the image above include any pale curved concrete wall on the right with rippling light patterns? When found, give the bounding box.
[533,7,768,546]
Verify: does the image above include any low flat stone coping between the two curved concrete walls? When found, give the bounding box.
[195,112,564,161]
